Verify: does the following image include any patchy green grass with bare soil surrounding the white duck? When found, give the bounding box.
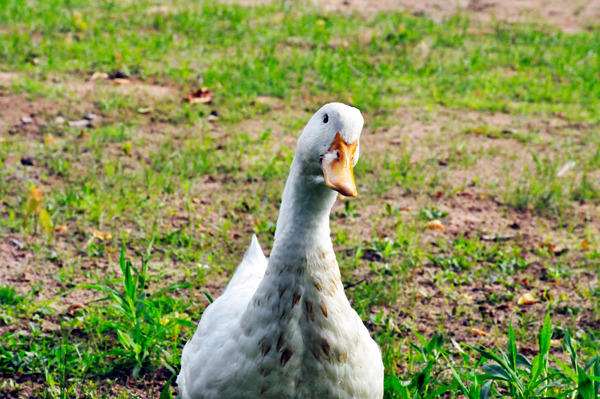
[0,0,600,398]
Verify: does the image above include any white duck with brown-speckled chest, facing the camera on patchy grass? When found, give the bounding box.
[177,103,383,399]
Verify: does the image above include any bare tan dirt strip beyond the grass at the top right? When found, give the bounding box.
[226,0,600,32]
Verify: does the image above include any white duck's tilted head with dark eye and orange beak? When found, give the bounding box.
[296,103,364,197]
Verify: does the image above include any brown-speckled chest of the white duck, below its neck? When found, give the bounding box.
[234,270,377,398]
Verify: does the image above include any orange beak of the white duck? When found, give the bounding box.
[323,132,358,197]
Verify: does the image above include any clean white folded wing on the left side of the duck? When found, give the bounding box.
[177,235,267,399]
